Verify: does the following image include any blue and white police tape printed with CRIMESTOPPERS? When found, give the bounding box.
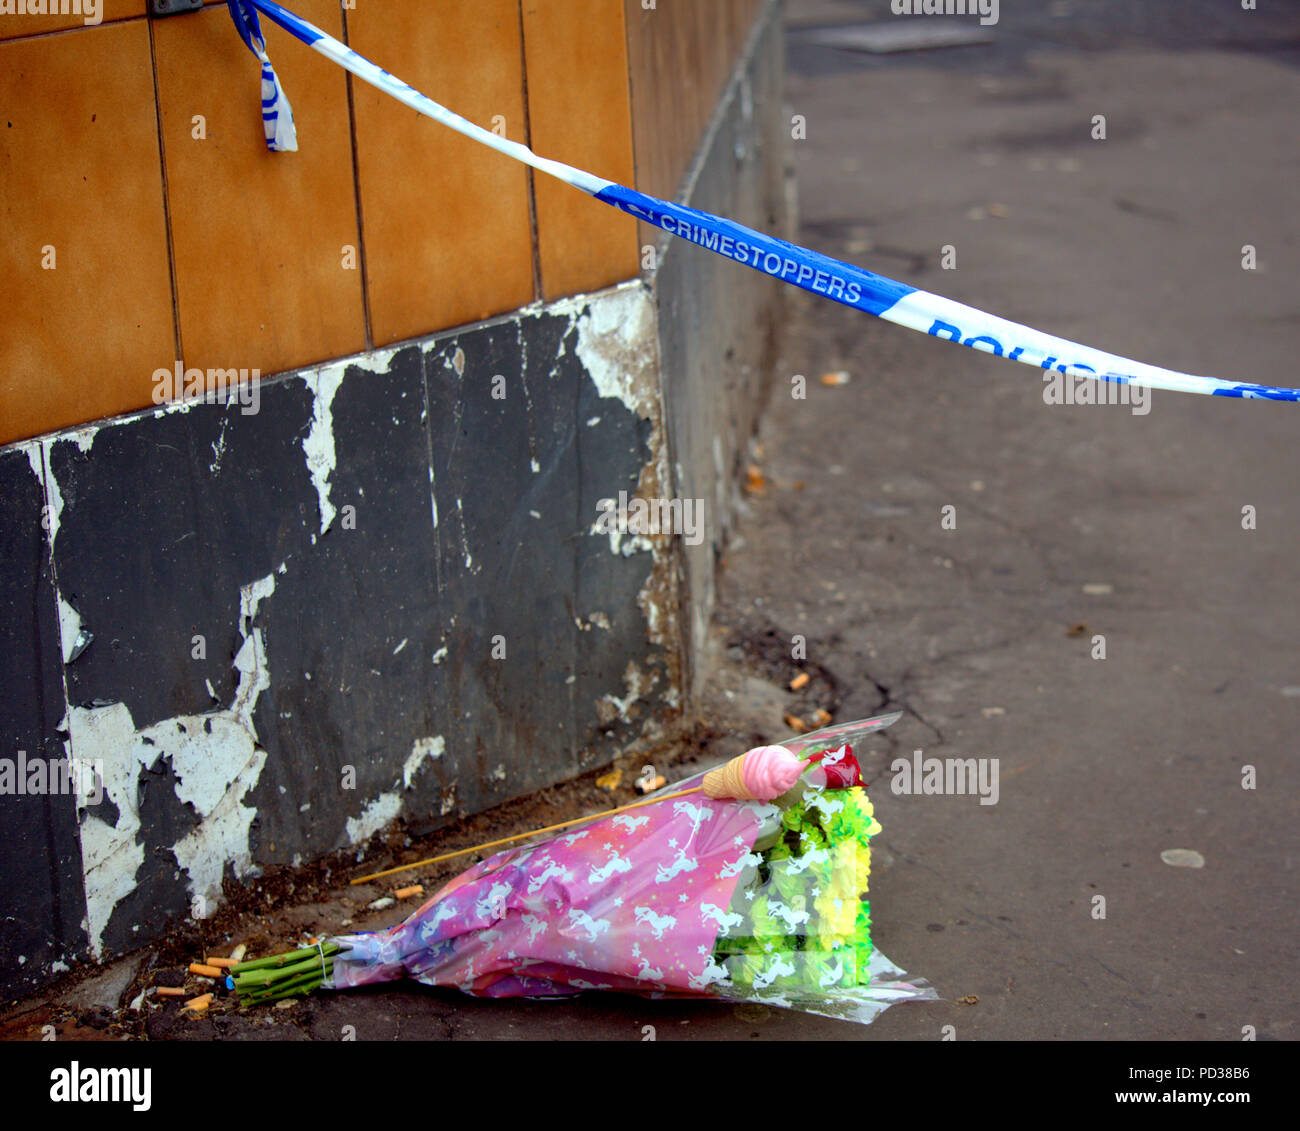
[228,0,1300,400]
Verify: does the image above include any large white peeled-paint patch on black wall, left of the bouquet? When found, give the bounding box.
[66,573,276,958]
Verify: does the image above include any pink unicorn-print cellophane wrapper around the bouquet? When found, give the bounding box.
[330,724,935,1022]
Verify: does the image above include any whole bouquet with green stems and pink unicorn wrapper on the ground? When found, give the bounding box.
[231,715,936,1022]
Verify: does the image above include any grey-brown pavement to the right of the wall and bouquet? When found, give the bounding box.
[720,3,1300,1040]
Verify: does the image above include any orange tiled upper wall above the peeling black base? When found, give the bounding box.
[0,0,762,443]
